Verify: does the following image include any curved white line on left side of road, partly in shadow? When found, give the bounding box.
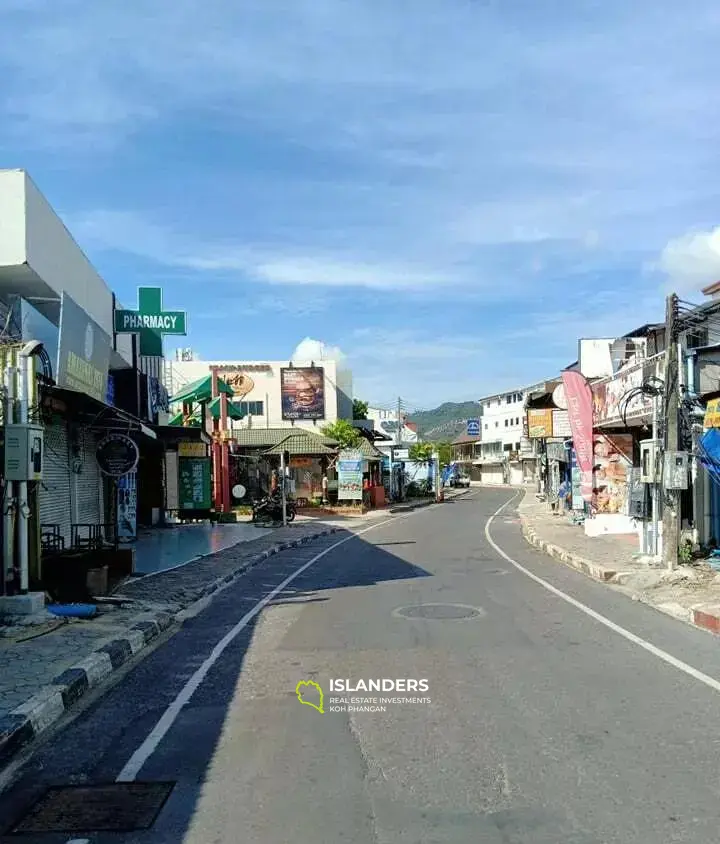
[115,510,438,782]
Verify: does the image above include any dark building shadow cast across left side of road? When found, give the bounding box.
[0,531,430,844]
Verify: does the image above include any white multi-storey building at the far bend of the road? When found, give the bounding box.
[479,382,544,484]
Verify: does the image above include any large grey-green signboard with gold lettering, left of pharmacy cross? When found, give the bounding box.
[55,291,112,403]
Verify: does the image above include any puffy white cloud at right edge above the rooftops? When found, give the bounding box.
[655,226,720,300]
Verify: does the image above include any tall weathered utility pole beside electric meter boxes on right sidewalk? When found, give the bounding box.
[663,293,680,569]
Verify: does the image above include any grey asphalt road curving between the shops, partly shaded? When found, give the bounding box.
[0,490,720,844]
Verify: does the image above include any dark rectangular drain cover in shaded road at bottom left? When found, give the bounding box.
[10,782,175,835]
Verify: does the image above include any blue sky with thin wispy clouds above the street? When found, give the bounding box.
[0,0,720,407]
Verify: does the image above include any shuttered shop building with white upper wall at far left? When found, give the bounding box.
[0,170,196,591]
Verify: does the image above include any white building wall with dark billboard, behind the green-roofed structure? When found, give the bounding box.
[165,349,353,430]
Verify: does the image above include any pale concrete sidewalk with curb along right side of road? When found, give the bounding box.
[518,492,720,633]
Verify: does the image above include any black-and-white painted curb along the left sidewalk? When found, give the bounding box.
[0,527,338,770]
